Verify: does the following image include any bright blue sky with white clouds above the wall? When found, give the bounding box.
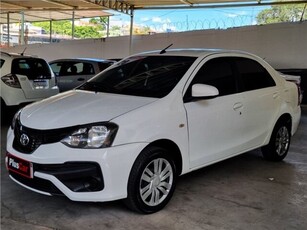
[110,6,268,32]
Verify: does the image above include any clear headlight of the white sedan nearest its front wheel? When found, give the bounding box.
[61,123,118,149]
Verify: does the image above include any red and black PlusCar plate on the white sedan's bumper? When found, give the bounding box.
[6,154,33,178]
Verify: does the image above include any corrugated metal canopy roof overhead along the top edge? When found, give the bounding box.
[0,0,307,24]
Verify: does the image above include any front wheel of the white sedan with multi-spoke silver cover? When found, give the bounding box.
[125,147,177,214]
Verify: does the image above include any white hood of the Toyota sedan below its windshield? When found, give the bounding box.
[20,90,157,130]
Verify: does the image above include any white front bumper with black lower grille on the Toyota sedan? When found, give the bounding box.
[7,129,146,201]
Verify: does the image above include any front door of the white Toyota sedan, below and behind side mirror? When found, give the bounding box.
[184,57,244,168]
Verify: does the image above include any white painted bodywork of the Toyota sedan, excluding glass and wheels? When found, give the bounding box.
[7,50,301,209]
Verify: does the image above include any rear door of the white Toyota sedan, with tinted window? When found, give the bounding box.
[235,57,280,150]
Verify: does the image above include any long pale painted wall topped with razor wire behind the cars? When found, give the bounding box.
[3,21,307,69]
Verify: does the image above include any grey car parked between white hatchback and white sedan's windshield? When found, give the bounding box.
[49,58,116,92]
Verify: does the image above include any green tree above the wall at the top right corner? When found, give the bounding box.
[257,4,307,24]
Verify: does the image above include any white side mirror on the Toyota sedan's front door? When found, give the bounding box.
[192,84,219,100]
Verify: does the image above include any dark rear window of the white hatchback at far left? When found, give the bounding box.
[11,58,51,80]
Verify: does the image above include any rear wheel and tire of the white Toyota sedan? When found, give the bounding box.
[261,120,291,161]
